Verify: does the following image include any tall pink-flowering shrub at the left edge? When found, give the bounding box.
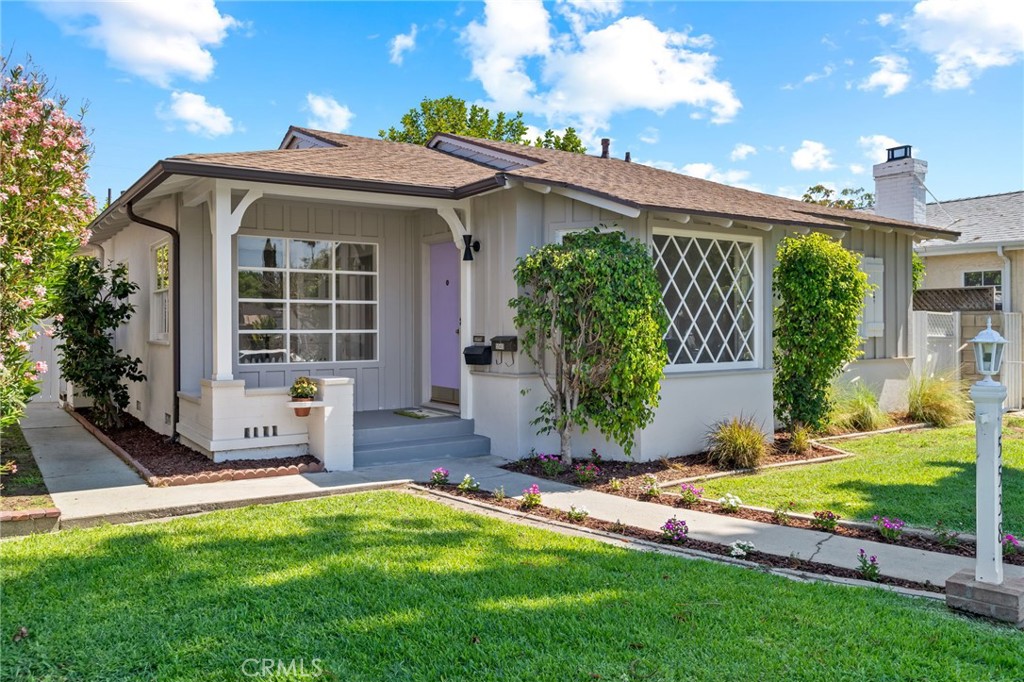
[0,58,95,427]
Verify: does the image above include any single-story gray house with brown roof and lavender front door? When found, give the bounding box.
[75,127,956,469]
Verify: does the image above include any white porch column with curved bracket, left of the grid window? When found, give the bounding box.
[209,180,263,381]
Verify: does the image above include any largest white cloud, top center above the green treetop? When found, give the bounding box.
[463,0,741,131]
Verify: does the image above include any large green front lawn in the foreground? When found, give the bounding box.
[0,493,1024,681]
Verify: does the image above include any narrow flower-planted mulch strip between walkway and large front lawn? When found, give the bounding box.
[420,482,945,594]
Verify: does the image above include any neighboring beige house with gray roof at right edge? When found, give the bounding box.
[915,191,1024,312]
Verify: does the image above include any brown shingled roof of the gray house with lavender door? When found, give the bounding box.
[100,126,956,240]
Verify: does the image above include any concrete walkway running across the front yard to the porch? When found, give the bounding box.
[22,404,1024,585]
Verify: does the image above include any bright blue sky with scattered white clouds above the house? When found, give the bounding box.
[0,0,1024,210]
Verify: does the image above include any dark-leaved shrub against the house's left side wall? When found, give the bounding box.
[55,256,145,429]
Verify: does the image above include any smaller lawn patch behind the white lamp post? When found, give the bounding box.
[703,418,1024,535]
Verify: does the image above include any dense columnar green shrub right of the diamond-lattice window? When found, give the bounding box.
[772,233,868,430]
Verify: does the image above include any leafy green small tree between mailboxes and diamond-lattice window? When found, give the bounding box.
[509,228,668,464]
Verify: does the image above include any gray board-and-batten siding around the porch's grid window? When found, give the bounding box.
[232,200,421,411]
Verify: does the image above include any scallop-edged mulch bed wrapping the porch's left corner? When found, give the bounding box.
[77,410,324,485]
